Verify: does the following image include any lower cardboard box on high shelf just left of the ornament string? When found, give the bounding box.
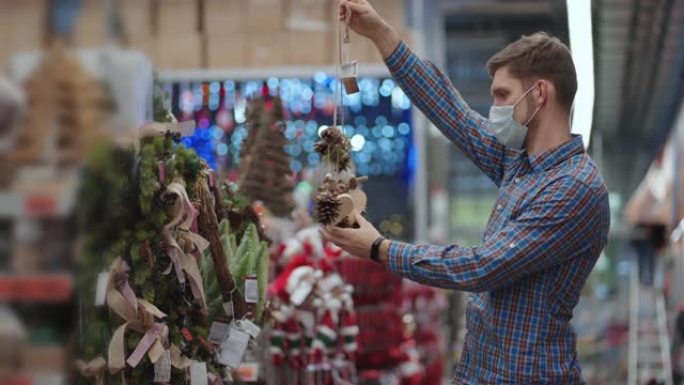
[285,31,335,66]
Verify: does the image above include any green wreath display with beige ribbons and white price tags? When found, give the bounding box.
[77,113,269,385]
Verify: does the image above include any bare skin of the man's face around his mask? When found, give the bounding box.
[491,66,534,123]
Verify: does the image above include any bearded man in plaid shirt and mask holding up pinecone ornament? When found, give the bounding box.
[321,0,610,385]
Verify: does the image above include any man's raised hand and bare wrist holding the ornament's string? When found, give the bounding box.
[339,0,401,59]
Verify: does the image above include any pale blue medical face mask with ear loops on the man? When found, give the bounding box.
[489,84,541,150]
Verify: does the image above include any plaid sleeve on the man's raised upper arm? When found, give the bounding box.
[385,42,505,186]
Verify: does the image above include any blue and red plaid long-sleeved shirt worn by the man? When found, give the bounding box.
[386,43,610,385]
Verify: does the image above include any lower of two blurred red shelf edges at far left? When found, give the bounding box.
[0,273,74,303]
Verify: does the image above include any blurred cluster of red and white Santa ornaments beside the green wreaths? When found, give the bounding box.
[269,227,359,385]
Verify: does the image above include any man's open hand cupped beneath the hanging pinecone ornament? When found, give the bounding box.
[320,212,382,259]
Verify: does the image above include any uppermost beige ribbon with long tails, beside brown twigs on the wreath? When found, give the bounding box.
[162,182,209,314]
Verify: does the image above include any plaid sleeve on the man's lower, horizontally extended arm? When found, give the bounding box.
[388,177,605,292]
